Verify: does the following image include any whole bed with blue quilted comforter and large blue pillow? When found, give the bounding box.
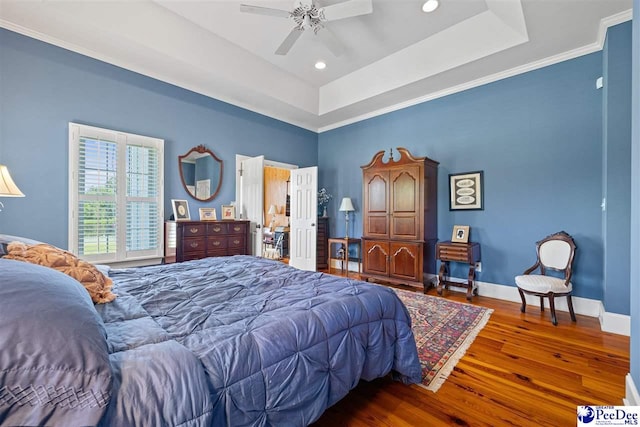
[0,252,421,426]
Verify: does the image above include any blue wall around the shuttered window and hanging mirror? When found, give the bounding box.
[0,29,318,248]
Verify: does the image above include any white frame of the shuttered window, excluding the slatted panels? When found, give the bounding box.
[68,122,165,266]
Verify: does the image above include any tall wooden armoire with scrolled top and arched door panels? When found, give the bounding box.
[362,148,438,291]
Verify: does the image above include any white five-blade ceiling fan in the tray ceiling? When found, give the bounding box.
[240,0,373,56]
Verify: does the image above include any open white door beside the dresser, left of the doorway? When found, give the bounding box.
[236,156,264,256]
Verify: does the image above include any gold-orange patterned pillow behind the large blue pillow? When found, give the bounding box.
[4,242,116,304]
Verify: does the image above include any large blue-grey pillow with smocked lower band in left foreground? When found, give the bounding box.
[0,259,112,426]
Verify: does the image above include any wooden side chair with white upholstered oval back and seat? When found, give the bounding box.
[516,231,576,326]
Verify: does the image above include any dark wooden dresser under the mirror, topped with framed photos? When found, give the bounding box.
[176,220,251,262]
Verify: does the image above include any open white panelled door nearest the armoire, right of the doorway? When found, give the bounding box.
[289,166,318,271]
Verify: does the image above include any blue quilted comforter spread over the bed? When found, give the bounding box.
[96,256,420,426]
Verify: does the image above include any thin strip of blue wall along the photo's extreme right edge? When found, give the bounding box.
[631,0,640,392]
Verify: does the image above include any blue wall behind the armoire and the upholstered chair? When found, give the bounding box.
[318,52,603,299]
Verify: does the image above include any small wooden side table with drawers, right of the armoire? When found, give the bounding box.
[436,241,480,301]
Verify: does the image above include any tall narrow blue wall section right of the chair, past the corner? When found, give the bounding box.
[603,22,632,314]
